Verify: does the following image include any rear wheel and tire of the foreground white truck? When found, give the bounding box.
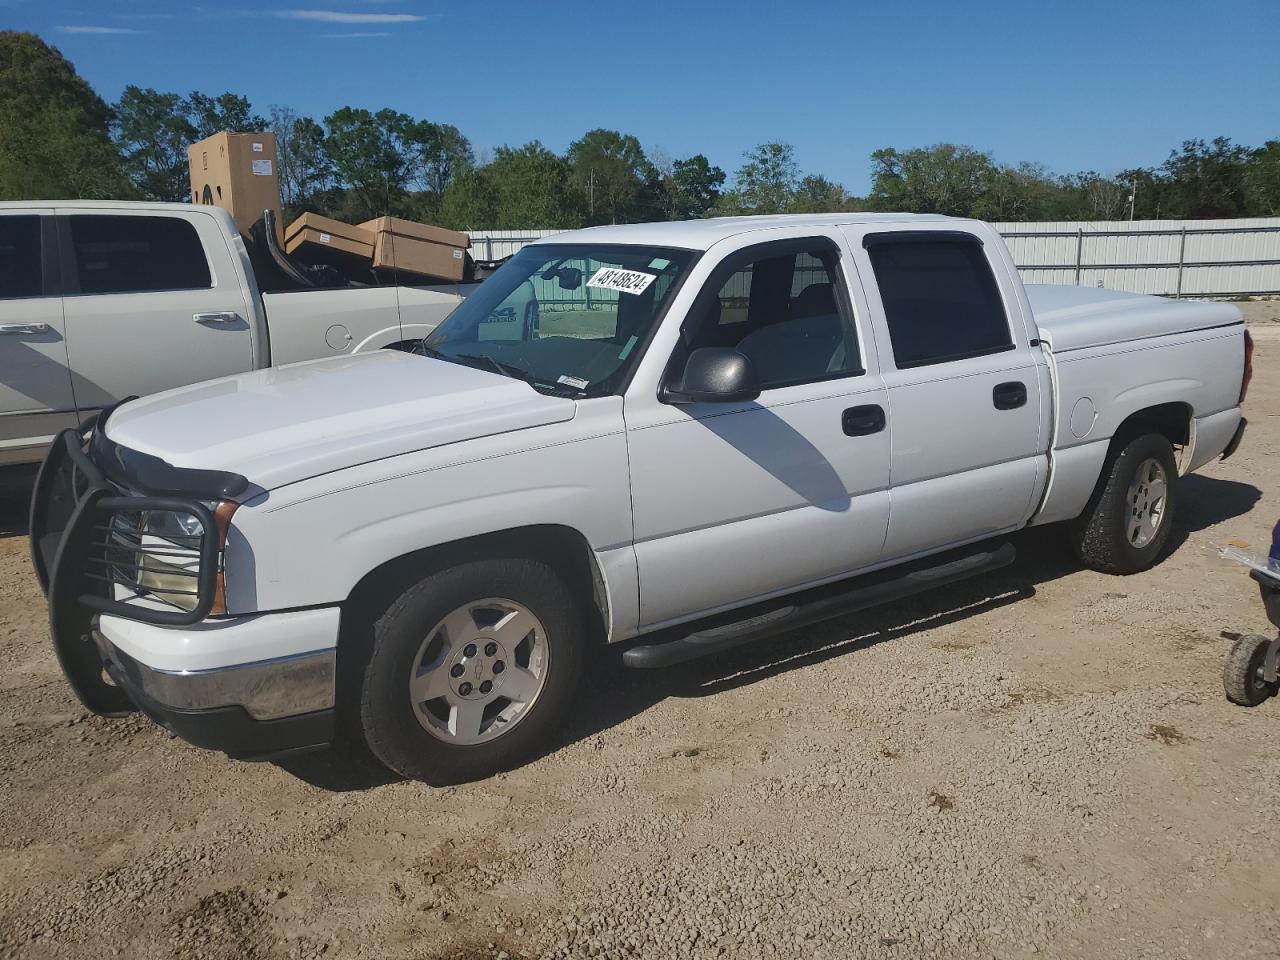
[1071,434,1178,575]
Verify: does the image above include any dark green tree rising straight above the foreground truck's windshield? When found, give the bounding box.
[566,129,655,224]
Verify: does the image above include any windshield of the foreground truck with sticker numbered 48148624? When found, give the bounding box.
[422,244,696,397]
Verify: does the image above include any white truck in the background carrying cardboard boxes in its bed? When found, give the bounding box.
[0,201,481,466]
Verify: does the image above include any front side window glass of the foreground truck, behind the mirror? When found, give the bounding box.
[673,242,861,389]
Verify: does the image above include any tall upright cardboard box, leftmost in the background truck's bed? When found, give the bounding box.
[187,133,280,239]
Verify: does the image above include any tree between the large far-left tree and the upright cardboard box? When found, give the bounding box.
[113,84,198,201]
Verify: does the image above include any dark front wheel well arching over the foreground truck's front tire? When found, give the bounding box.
[343,524,609,647]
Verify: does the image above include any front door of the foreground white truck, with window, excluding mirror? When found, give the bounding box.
[623,237,890,628]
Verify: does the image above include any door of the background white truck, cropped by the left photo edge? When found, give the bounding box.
[0,210,76,465]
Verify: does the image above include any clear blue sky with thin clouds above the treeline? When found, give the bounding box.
[10,0,1280,192]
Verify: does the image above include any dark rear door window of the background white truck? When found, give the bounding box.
[69,216,210,293]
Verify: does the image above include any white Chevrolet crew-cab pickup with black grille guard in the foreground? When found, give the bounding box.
[31,214,1252,783]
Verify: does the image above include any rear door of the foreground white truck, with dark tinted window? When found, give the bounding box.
[846,224,1047,559]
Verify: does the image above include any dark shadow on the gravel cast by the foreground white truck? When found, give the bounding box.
[279,476,1262,791]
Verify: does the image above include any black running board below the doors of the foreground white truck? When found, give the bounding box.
[622,543,1018,668]
